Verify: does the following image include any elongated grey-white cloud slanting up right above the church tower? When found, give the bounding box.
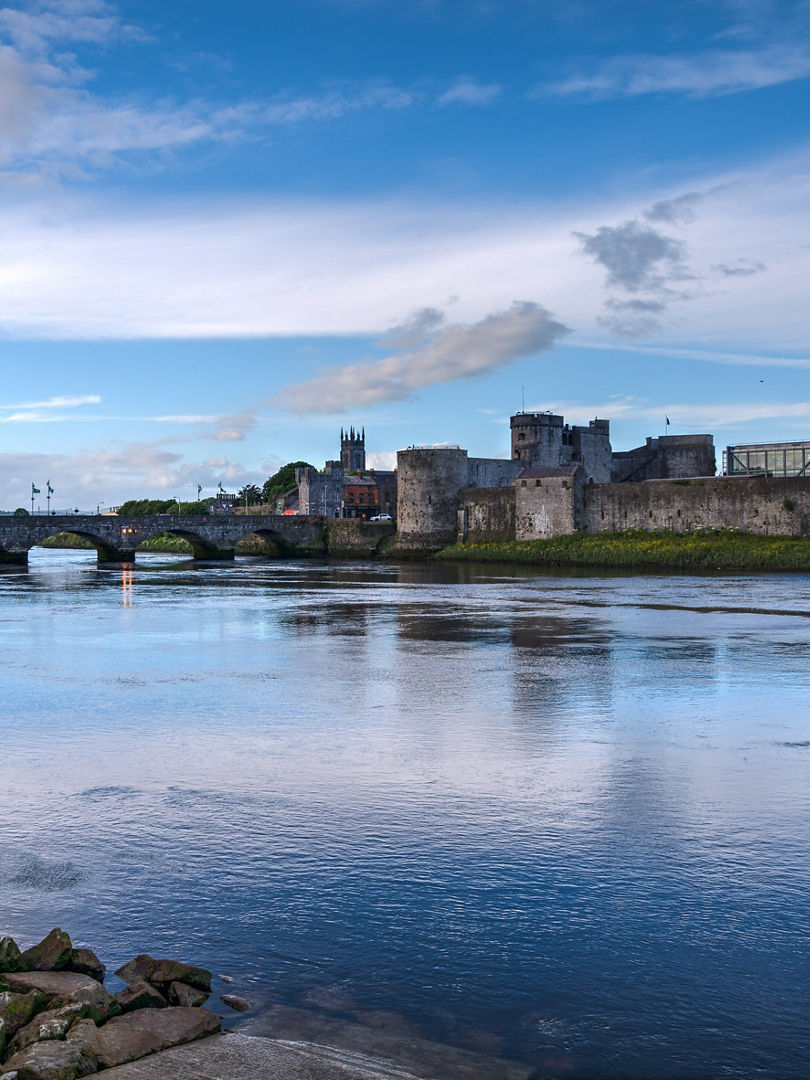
[276,300,569,414]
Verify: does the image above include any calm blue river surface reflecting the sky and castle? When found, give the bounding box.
[0,549,810,1080]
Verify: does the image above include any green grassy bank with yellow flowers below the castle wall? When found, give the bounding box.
[435,530,810,570]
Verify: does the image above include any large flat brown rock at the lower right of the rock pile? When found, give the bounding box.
[96,1007,219,1068]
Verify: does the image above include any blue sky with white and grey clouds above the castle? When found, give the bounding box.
[0,0,810,510]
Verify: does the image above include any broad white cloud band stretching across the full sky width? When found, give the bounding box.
[0,156,810,347]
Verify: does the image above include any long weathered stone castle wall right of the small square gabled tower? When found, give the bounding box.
[580,476,810,536]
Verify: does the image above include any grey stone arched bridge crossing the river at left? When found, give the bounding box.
[0,514,327,566]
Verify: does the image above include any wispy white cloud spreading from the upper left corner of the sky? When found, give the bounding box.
[0,0,499,185]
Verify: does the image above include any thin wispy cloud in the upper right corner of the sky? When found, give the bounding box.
[537,44,810,99]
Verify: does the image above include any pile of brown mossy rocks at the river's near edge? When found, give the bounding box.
[0,929,237,1080]
